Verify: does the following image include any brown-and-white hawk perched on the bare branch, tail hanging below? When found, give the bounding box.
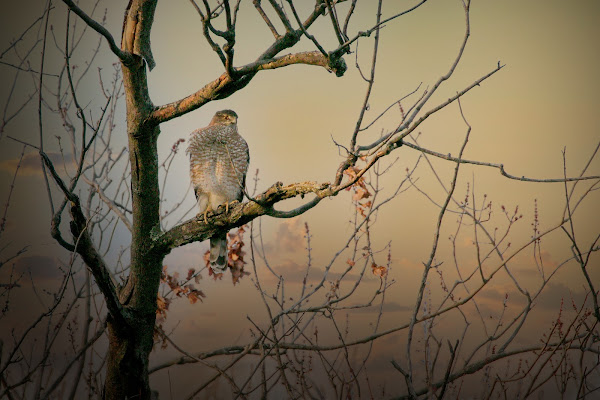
[186,110,250,273]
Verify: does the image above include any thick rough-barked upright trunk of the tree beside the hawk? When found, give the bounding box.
[104,0,164,399]
